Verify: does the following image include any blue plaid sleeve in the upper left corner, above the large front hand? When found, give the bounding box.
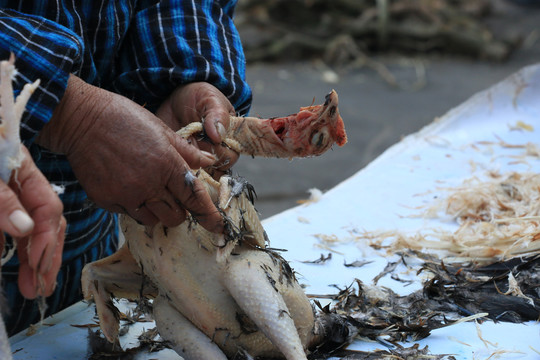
[0,9,83,141]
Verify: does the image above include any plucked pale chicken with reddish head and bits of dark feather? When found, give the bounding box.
[82,91,347,360]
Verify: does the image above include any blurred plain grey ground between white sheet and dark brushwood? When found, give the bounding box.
[234,1,540,218]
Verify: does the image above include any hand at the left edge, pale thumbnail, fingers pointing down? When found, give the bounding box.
[0,145,66,299]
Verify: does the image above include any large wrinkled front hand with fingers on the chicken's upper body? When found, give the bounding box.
[34,75,223,232]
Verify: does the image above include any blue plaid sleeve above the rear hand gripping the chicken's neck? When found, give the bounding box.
[114,0,251,114]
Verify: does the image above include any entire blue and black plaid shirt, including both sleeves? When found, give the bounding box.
[0,0,251,333]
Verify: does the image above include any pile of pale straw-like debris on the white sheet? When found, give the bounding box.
[370,173,540,264]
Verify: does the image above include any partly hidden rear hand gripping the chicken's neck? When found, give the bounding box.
[156,82,238,177]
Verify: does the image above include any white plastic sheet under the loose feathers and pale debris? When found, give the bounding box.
[265,65,540,359]
